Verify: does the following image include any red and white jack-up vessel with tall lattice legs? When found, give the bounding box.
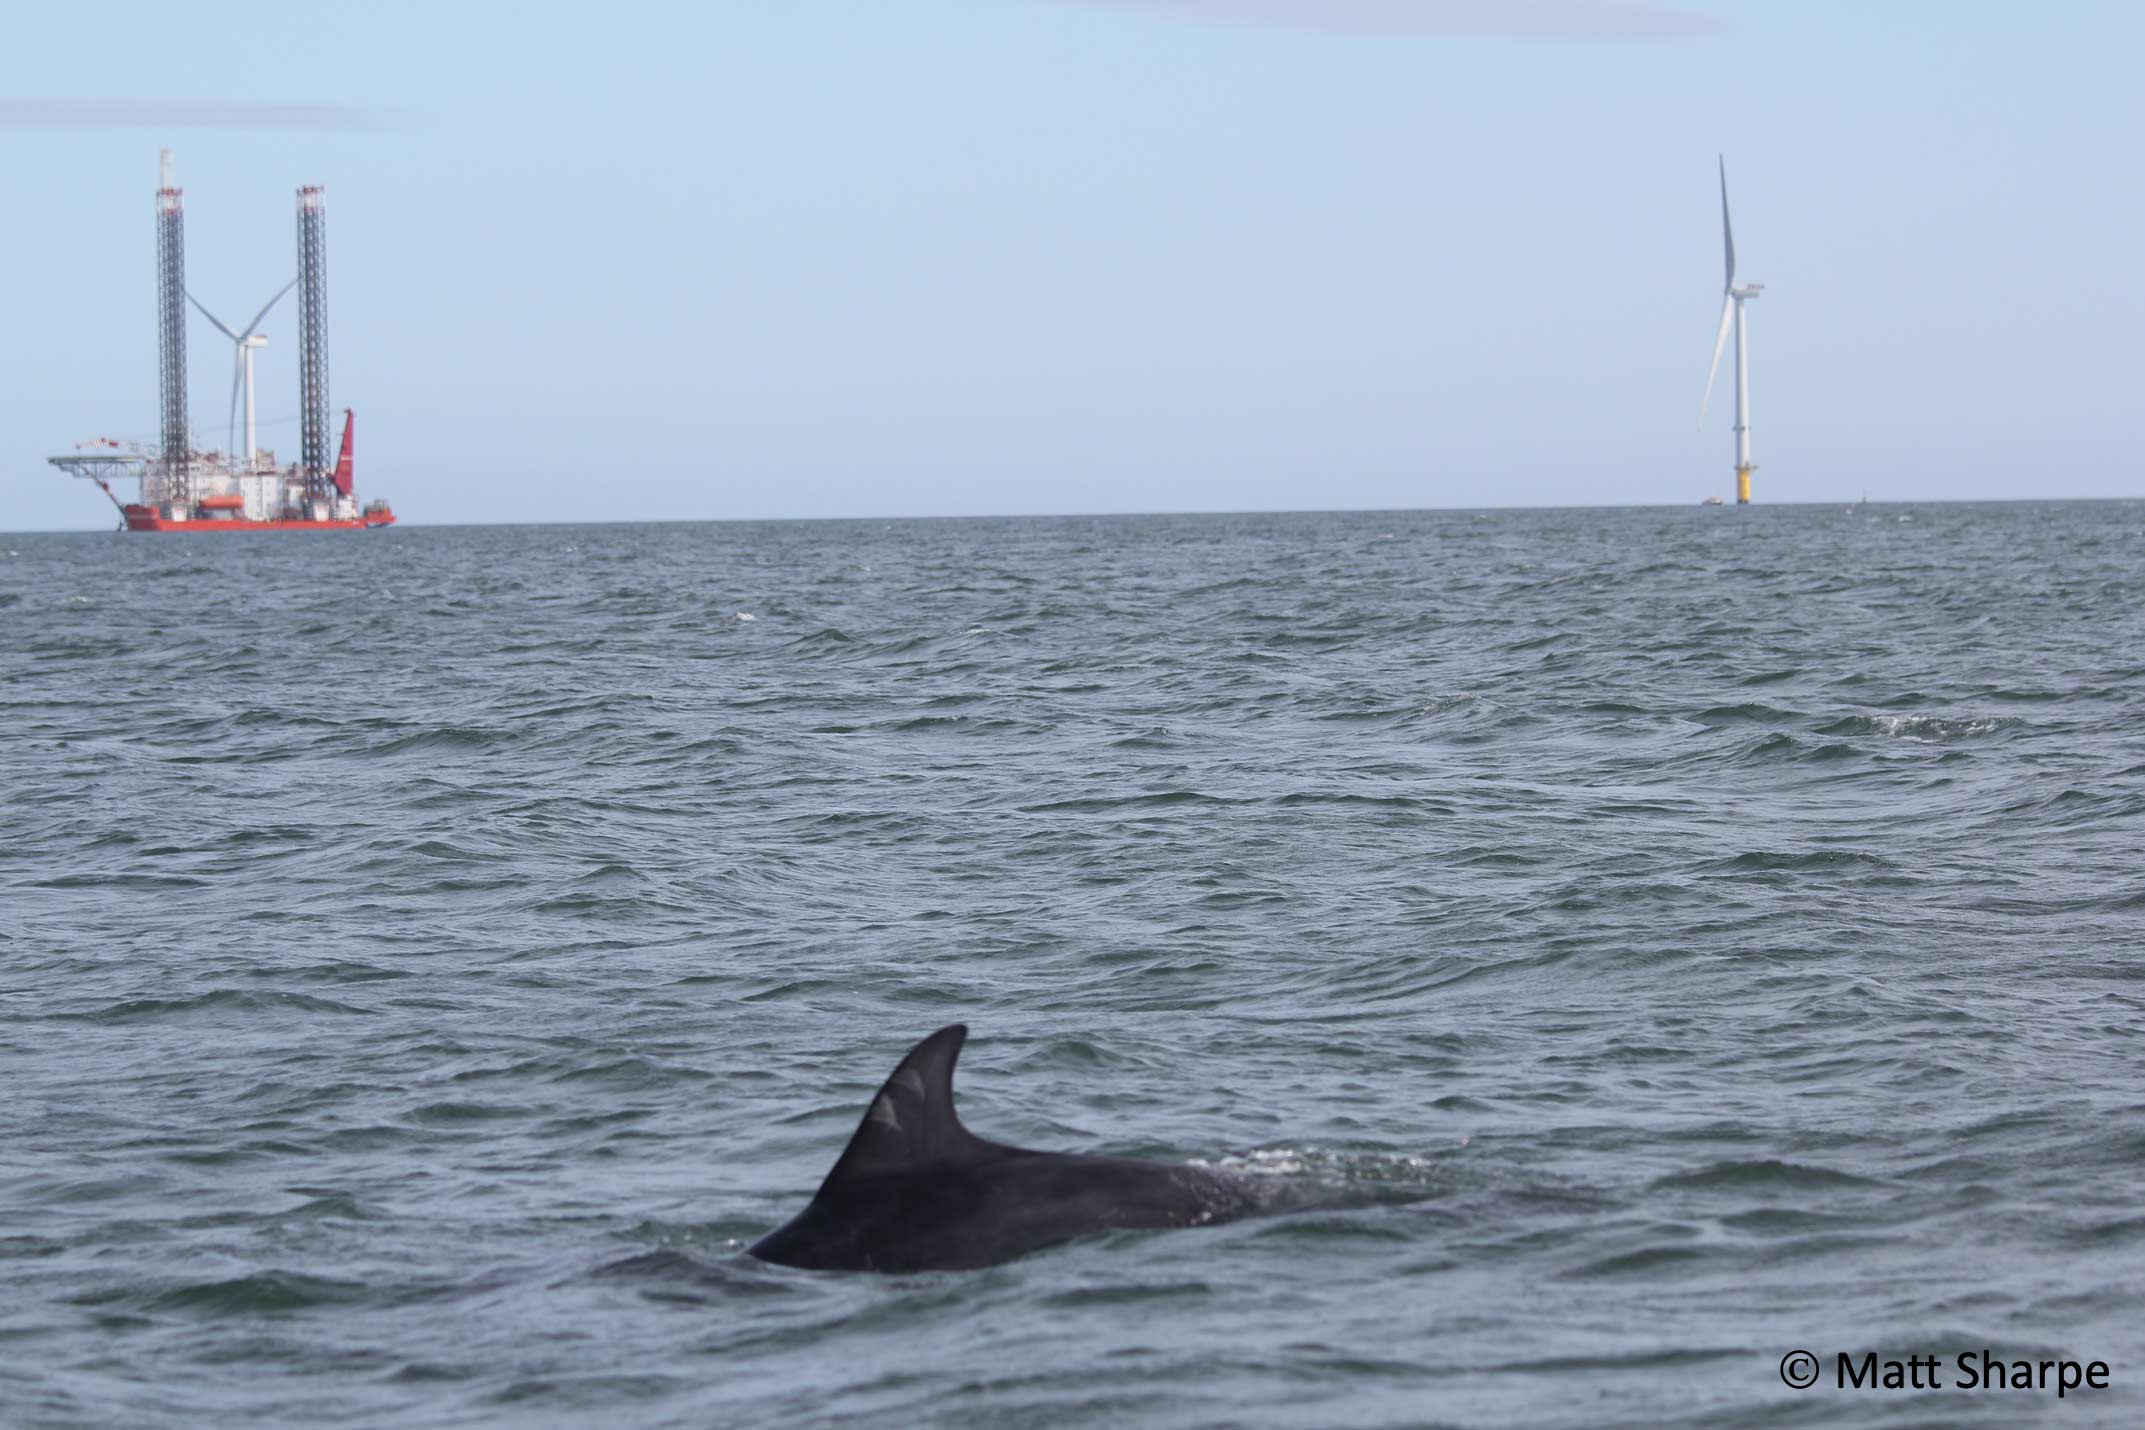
[51,150,395,532]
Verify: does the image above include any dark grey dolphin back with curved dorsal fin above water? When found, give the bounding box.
[751,1023,1313,1271]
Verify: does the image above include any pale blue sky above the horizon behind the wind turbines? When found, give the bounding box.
[0,0,2145,530]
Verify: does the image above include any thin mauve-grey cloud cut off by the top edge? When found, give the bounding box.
[1046,0,1720,41]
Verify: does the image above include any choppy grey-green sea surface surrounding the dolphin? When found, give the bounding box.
[0,502,2145,1428]
